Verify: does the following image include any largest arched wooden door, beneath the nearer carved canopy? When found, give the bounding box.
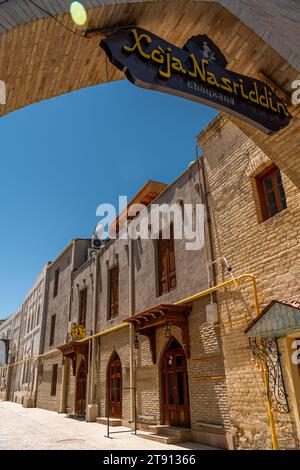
[161,338,190,426]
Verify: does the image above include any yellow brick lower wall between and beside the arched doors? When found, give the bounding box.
[99,299,230,446]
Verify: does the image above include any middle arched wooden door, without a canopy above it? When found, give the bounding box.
[107,352,122,419]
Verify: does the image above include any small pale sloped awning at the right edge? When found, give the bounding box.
[245,296,300,338]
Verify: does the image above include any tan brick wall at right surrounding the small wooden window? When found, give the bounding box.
[199,115,300,449]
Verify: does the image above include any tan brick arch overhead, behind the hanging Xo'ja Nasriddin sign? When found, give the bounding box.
[0,0,300,187]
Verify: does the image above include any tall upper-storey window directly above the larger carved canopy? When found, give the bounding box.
[157,224,176,295]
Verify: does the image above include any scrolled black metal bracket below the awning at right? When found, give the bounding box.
[249,337,290,414]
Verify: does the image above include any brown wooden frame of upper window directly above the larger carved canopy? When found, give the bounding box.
[156,223,177,297]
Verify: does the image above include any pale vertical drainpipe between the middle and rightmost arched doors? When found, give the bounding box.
[128,237,136,423]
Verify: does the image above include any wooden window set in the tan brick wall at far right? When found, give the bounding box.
[256,165,287,220]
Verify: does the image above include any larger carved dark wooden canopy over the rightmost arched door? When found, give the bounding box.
[126,304,192,364]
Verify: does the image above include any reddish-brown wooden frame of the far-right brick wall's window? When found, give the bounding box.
[255,165,286,221]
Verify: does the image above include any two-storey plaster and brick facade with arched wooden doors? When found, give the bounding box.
[37,168,232,448]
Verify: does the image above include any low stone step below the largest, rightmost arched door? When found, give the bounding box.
[138,425,191,444]
